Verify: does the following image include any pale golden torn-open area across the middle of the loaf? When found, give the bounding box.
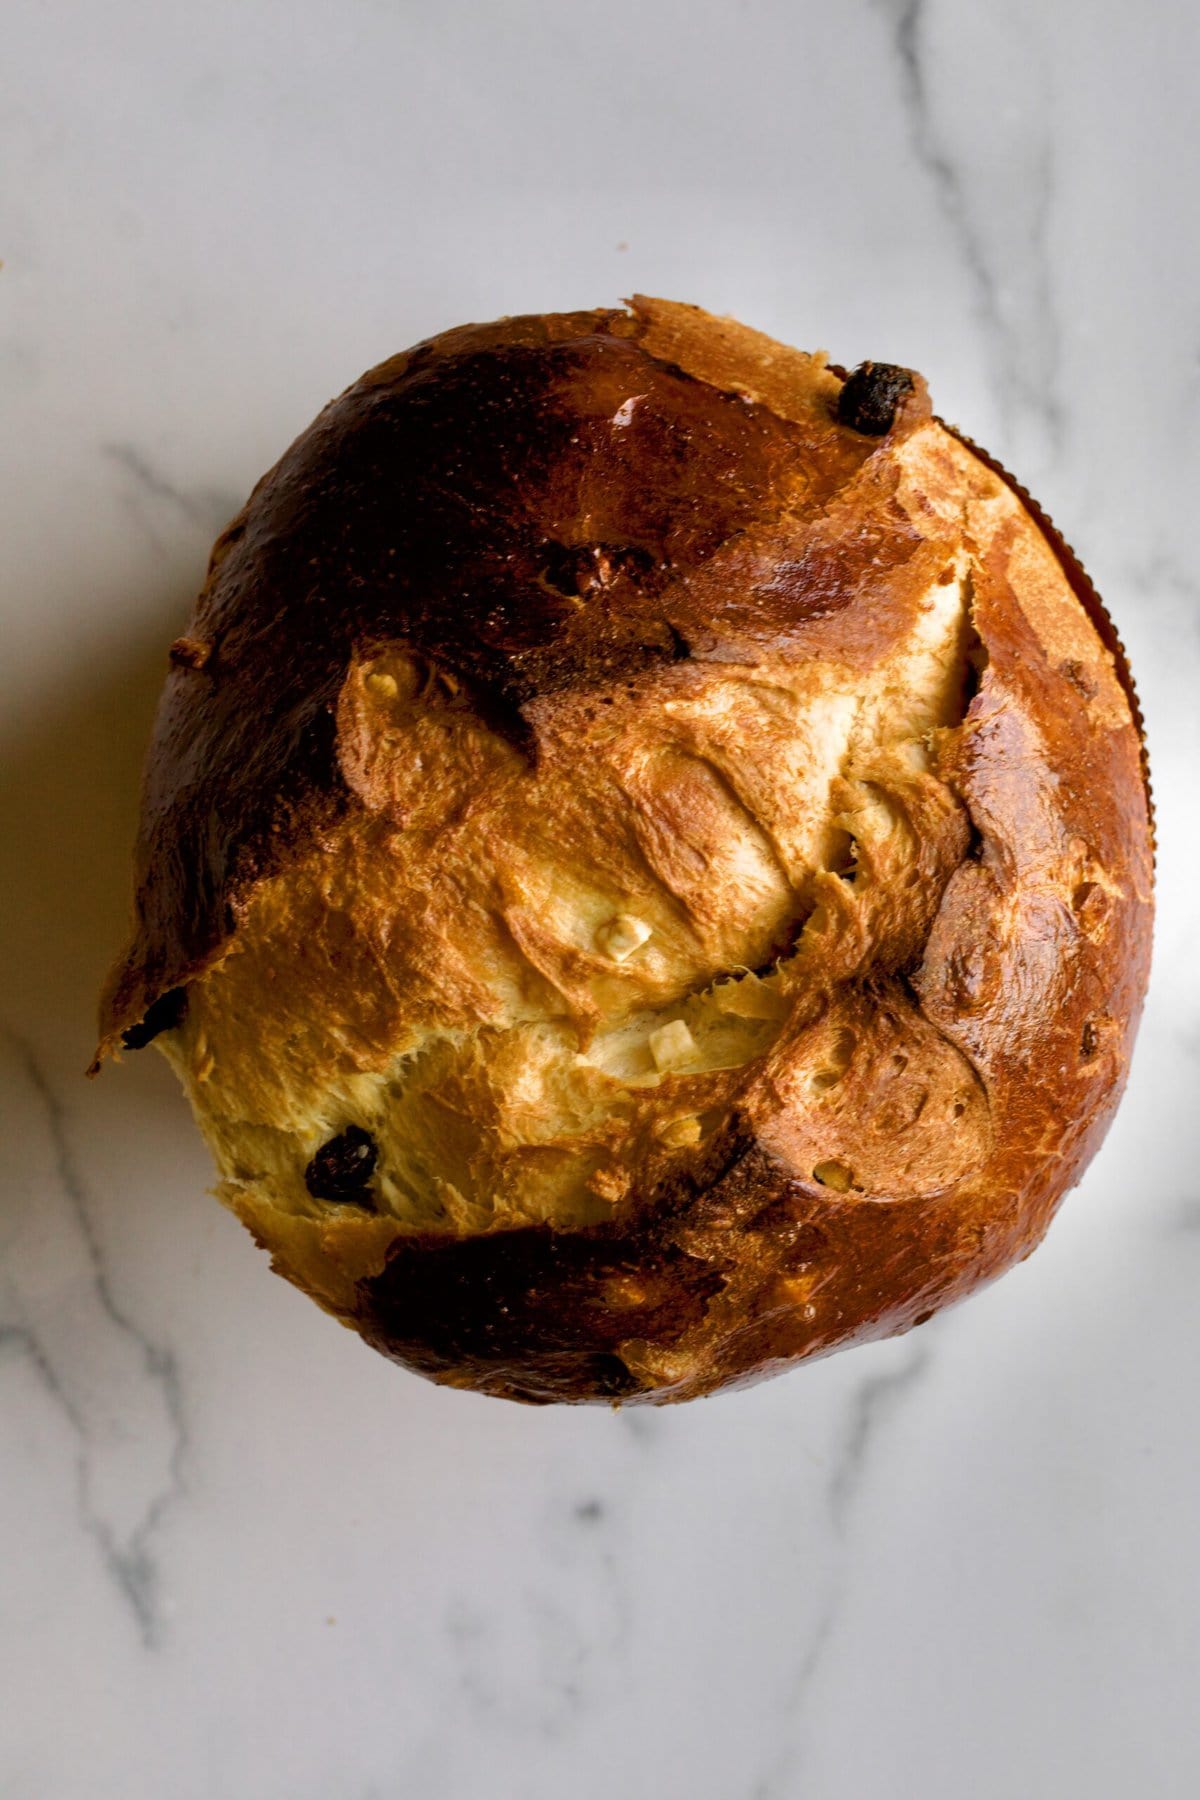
[164,565,972,1231]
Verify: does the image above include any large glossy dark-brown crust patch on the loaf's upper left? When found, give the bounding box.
[101,311,892,1057]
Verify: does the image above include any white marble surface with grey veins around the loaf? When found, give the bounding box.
[0,0,1200,1800]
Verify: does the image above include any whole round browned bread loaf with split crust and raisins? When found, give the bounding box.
[97,299,1151,1402]
